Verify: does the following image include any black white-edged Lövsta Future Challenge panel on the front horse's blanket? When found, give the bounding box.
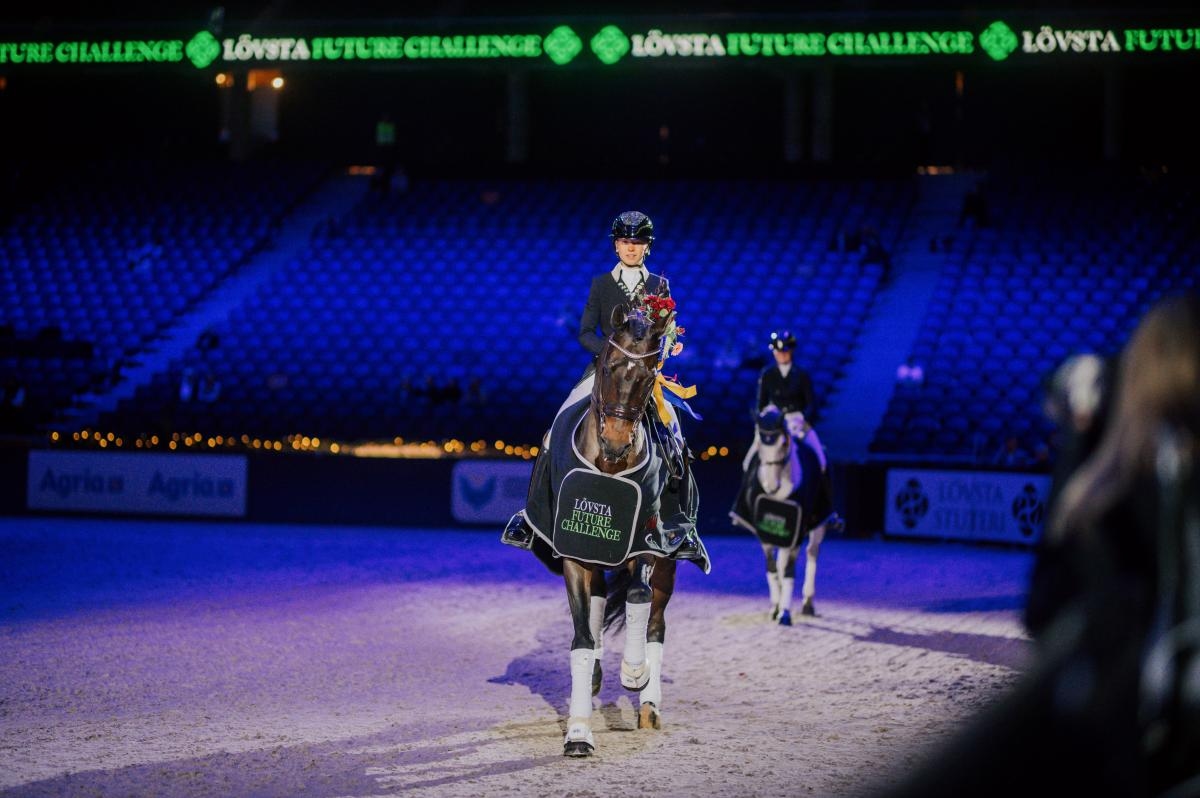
[553,468,642,568]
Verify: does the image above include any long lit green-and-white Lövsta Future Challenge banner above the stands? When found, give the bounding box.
[0,18,1200,70]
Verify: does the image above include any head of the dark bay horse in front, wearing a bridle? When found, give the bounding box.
[592,300,674,463]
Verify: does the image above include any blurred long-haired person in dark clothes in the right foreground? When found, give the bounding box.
[870,294,1200,798]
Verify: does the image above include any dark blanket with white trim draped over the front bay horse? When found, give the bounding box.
[524,397,710,574]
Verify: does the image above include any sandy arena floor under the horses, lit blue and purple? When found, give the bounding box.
[0,520,1030,798]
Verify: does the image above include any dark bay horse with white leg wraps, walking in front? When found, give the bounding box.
[554,297,708,756]
